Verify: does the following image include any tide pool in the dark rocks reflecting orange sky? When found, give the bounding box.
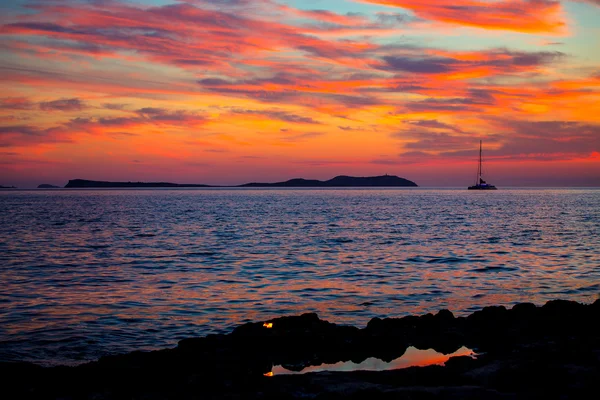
[265,346,475,376]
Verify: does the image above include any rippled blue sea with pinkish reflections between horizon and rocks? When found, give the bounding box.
[0,188,600,365]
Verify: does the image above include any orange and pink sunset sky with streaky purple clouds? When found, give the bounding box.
[0,0,600,187]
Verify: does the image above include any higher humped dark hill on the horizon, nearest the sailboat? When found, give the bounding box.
[240,175,418,187]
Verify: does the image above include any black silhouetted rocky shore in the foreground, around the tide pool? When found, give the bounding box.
[0,300,600,400]
